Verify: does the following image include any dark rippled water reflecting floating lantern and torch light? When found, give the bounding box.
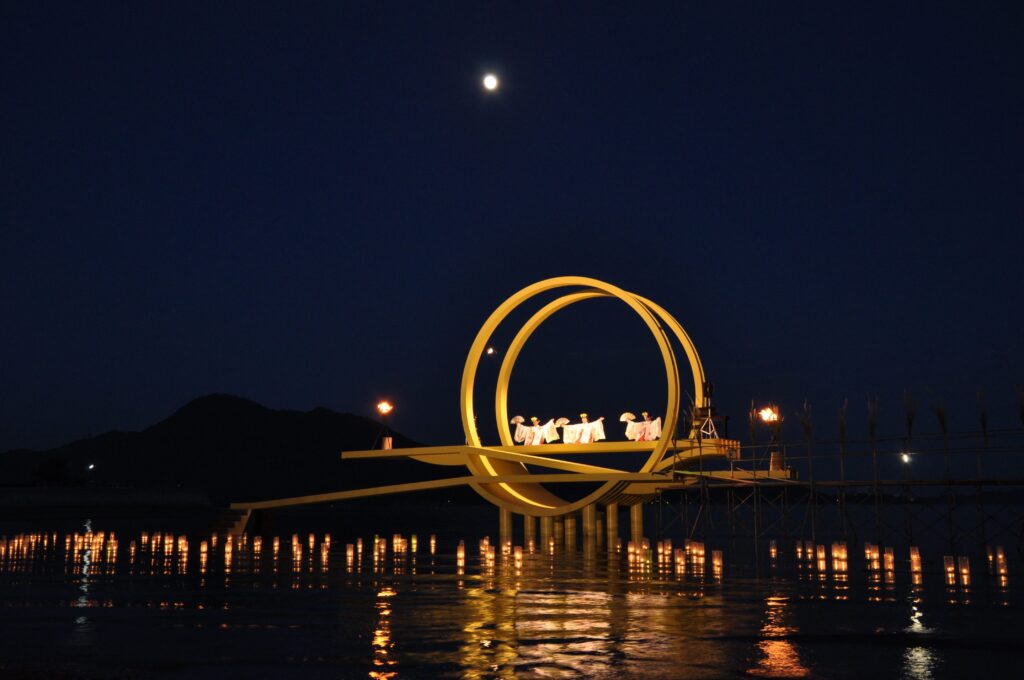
[0,515,1024,680]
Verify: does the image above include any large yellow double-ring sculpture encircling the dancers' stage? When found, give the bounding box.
[461,277,705,516]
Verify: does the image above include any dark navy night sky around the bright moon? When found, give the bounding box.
[0,1,1024,451]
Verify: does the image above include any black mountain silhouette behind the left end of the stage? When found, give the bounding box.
[0,394,468,504]
